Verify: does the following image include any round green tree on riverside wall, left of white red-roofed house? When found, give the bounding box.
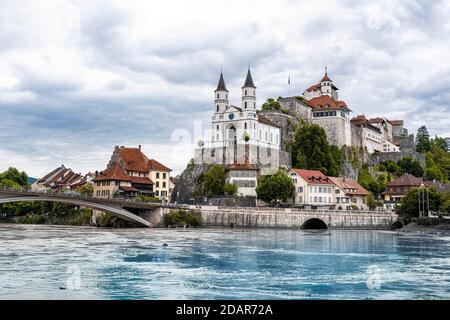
[256,169,295,204]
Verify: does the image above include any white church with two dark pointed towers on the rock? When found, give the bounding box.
[194,68,281,196]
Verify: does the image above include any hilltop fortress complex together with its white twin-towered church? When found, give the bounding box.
[194,68,408,195]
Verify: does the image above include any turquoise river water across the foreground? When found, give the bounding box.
[0,225,450,299]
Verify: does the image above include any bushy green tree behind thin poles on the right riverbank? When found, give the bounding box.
[397,188,442,217]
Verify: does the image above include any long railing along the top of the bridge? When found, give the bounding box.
[0,185,163,205]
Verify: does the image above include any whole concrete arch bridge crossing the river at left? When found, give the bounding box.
[0,188,164,227]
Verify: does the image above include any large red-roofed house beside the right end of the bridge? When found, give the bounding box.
[94,146,172,200]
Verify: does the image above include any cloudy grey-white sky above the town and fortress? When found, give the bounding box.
[0,0,450,177]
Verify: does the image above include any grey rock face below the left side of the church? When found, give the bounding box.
[171,160,211,203]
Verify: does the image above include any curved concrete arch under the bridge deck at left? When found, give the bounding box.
[0,196,153,227]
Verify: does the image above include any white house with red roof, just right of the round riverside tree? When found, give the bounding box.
[288,168,336,209]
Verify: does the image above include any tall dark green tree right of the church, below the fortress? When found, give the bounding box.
[292,124,342,176]
